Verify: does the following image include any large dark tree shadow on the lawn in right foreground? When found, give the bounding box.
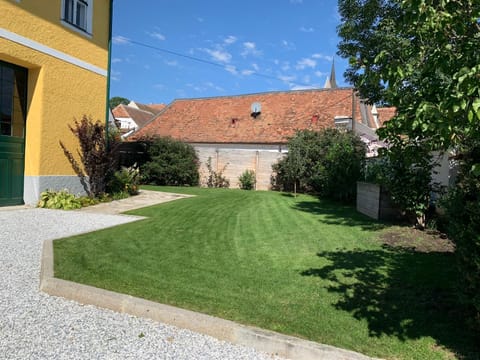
[301,245,480,360]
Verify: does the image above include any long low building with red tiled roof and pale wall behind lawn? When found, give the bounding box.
[129,87,394,190]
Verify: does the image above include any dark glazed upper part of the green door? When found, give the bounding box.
[0,61,27,137]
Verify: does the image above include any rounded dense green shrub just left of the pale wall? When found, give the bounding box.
[141,137,199,186]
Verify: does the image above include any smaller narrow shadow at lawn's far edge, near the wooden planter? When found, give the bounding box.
[293,195,388,231]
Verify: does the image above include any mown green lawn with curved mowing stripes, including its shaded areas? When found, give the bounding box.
[54,187,478,359]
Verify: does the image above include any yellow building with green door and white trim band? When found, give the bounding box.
[0,0,112,206]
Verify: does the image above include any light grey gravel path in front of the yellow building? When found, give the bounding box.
[0,209,284,360]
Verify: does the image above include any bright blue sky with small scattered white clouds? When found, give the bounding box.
[110,0,348,104]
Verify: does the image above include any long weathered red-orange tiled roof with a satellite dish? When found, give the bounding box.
[132,88,361,144]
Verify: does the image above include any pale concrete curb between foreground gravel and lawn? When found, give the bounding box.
[40,240,378,360]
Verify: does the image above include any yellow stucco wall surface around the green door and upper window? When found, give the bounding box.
[0,0,110,176]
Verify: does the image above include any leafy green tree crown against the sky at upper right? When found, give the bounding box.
[338,0,480,155]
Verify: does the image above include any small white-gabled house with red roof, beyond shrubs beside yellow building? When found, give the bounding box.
[112,101,165,136]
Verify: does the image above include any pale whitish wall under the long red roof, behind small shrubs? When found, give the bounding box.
[192,144,286,190]
